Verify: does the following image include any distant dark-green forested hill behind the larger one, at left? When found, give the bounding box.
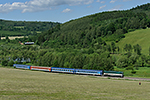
[0,19,60,36]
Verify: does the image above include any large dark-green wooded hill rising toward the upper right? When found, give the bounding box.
[36,4,150,48]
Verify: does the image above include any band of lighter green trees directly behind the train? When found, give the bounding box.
[0,42,150,70]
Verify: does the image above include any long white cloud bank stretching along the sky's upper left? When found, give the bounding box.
[0,0,94,13]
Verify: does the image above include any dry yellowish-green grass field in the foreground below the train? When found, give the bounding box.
[0,67,150,100]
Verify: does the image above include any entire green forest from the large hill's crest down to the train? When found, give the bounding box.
[0,4,150,74]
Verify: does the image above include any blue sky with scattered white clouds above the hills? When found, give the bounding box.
[0,0,150,23]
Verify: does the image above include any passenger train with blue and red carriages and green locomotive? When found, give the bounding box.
[13,64,124,78]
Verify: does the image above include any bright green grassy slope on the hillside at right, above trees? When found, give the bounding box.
[117,29,150,55]
